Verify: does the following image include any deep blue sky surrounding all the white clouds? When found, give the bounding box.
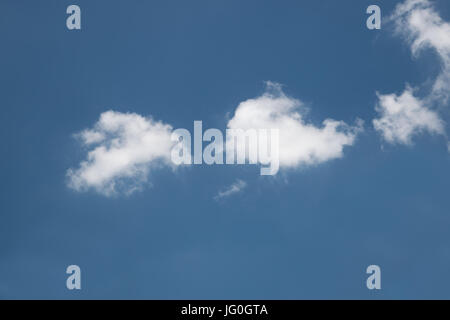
[0,0,450,299]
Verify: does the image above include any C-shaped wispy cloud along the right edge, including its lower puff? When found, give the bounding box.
[373,0,450,144]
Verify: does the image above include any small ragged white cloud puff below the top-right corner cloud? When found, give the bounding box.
[373,88,444,144]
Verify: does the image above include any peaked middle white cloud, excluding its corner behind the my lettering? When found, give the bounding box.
[228,82,362,168]
